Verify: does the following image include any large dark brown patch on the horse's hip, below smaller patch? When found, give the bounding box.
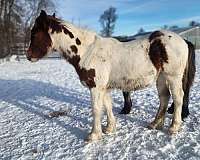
[149,39,168,71]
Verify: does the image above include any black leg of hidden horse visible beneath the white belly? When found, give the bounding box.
[120,92,132,114]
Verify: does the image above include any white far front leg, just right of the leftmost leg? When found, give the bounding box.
[103,92,116,134]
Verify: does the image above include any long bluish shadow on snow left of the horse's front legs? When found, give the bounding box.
[0,79,90,139]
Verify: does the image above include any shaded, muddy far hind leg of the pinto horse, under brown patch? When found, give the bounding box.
[148,74,170,129]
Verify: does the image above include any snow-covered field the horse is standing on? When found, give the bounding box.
[0,54,200,160]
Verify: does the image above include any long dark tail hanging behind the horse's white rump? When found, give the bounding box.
[182,40,196,119]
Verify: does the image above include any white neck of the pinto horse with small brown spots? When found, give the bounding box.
[54,23,96,57]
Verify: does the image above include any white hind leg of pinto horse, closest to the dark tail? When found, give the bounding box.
[168,76,184,134]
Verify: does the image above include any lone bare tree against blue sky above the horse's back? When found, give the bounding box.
[99,7,117,37]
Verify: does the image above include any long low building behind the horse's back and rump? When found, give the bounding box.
[114,26,200,49]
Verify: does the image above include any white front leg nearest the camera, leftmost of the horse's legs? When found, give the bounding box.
[86,88,105,142]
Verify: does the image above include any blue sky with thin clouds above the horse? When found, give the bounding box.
[57,0,200,35]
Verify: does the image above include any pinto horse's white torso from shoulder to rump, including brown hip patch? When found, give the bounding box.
[87,31,188,90]
